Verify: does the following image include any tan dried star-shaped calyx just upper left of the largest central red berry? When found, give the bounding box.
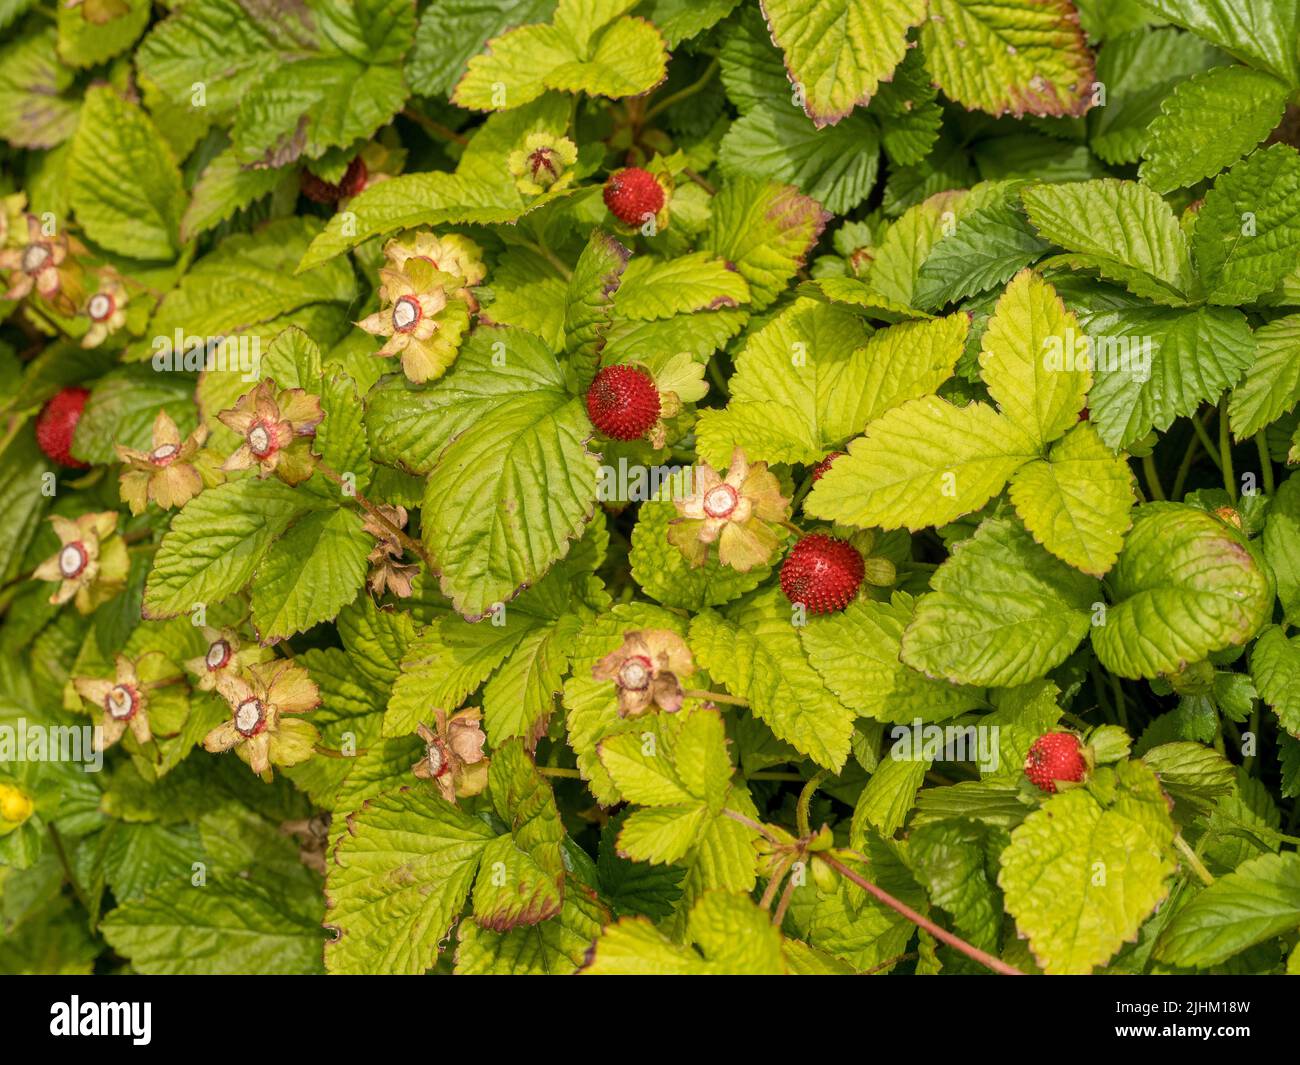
[668,447,790,573]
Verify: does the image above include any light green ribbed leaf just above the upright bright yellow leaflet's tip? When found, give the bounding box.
[1021,178,1192,304]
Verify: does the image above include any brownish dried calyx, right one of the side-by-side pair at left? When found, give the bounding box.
[217,380,324,485]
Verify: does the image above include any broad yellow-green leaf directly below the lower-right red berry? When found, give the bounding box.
[997,762,1174,975]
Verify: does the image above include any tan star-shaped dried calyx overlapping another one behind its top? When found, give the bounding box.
[356,256,471,385]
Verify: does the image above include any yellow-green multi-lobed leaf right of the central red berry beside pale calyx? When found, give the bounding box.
[696,298,969,468]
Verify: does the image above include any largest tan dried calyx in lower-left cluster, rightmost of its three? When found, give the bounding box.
[203,659,321,780]
